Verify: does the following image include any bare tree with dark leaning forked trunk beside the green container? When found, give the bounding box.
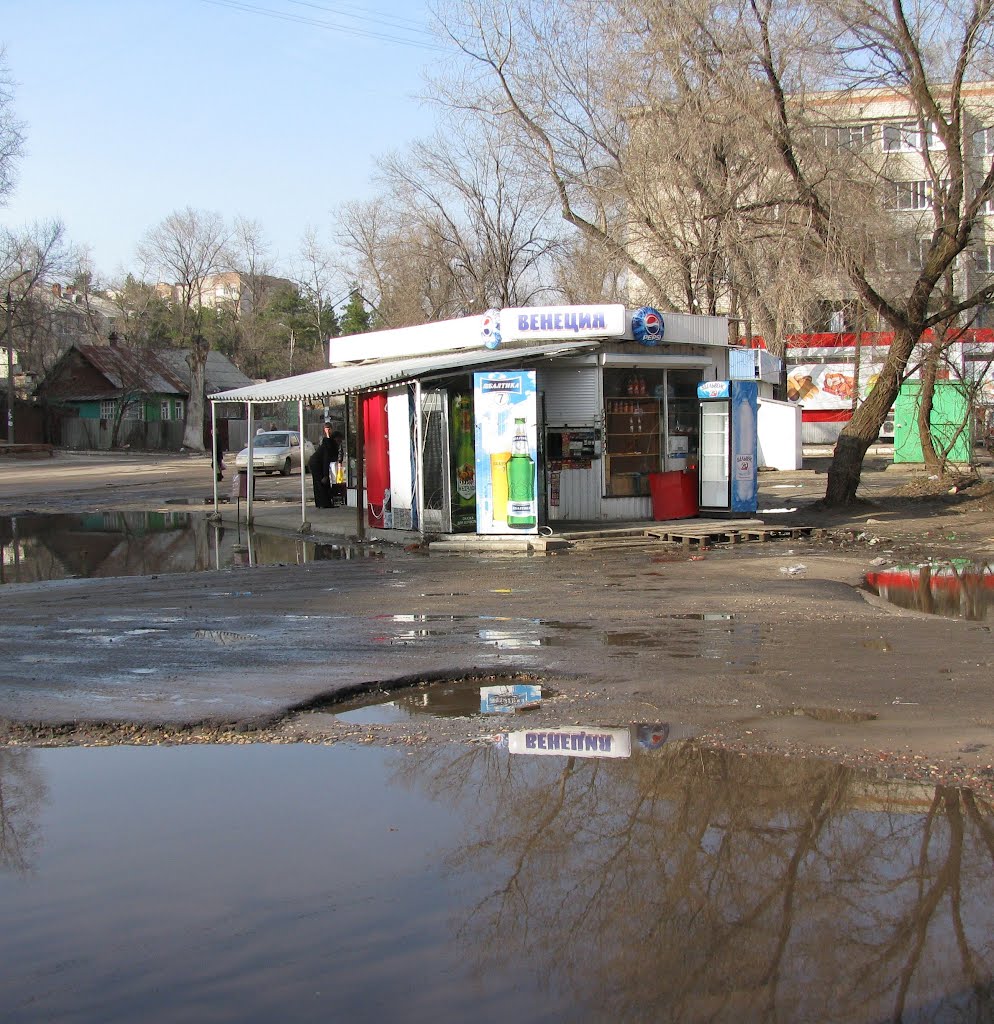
[742,0,994,505]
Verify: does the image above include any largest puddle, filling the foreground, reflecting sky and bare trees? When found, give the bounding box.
[0,737,994,1024]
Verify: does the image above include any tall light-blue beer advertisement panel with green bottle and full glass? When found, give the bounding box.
[473,370,538,534]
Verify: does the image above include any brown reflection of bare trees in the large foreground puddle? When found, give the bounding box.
[408,744,994,1021]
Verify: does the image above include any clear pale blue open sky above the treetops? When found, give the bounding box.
[0,0,450,281]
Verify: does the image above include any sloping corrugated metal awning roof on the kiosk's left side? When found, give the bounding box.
[210,339,600,401]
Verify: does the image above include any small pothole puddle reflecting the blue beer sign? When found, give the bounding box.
[335,680,555,725]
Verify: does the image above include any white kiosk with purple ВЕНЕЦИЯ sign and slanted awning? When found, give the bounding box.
[209,304,729,536]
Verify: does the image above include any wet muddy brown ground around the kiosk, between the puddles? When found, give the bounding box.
[0,448,994,792]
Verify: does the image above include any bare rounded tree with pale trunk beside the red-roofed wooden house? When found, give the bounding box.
[139,207,230,452]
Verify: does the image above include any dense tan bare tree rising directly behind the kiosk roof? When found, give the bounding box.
[435,0,816,351]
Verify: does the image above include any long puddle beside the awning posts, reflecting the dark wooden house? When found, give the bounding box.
[0,512,383,584]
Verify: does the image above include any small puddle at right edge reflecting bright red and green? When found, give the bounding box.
[865,559,994,622]
